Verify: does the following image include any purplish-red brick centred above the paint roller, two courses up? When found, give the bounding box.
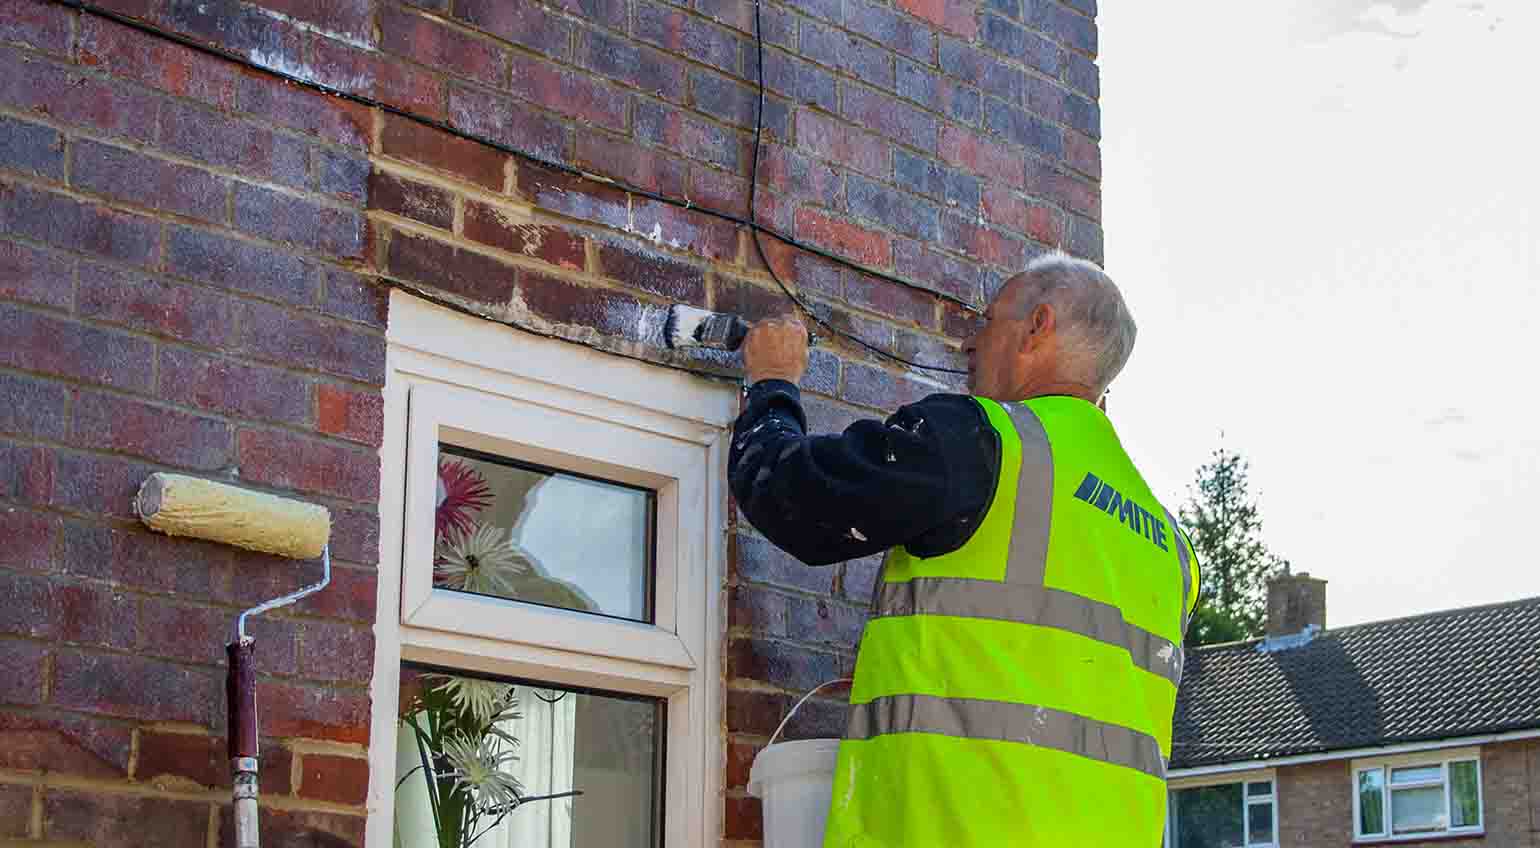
[156,348,311,426]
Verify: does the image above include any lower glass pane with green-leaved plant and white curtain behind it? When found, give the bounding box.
[396,666,664,848]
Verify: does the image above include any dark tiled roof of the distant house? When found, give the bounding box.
[1170,597,1540,768]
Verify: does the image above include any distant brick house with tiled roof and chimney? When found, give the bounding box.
[1167,574,1540,848]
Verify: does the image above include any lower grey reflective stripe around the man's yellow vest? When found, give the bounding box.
[845,694,1166,779]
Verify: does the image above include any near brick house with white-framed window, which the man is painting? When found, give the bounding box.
[0,0,1103,848]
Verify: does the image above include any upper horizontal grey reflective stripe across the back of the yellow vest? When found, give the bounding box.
[872,577,1181,686]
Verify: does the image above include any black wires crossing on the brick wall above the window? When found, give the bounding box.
[51,0,979,374]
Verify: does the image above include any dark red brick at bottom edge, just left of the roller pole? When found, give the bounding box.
[43,788,209,846]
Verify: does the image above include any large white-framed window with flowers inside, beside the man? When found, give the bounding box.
[367,291,738,848]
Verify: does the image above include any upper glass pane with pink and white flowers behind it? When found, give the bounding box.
[433,445,655,622]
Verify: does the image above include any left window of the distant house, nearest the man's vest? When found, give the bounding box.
[1166,774,1278,848]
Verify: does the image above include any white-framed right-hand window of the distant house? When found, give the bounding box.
[1354,750,1481,840]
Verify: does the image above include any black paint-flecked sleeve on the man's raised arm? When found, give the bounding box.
[728,380,999,565]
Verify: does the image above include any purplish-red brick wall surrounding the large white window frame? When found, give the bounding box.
[0,0,1101,845]
